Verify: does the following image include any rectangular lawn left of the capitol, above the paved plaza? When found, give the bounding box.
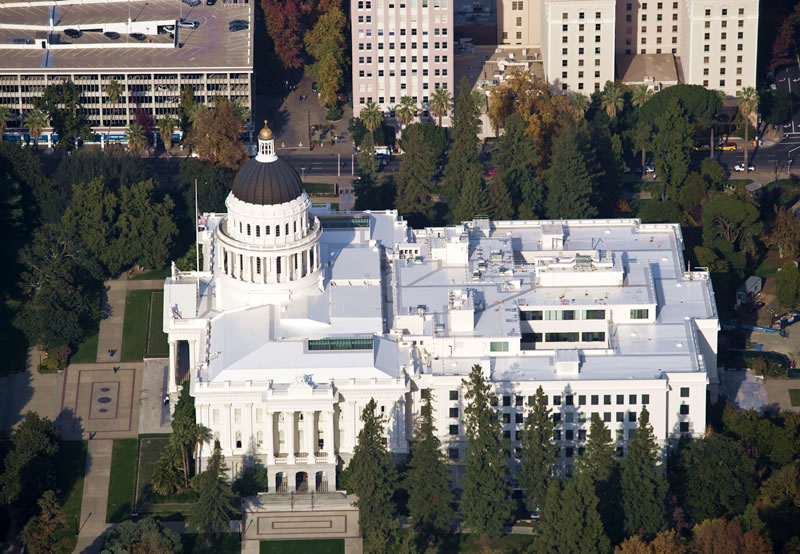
[121,290,169,362]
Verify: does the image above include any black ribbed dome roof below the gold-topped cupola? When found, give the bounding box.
[233,158,303,206]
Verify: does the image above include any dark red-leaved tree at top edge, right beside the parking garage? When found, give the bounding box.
[261,0,308,69]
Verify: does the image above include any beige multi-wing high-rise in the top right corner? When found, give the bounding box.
[490,0,759,96]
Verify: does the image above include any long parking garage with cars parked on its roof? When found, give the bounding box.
[0,0,253,140]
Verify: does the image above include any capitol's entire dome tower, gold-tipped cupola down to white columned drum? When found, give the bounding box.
[215,121,322,307]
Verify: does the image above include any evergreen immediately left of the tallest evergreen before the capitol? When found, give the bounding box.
[405,389,453,537]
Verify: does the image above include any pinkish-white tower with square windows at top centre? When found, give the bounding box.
[350,0,454,121]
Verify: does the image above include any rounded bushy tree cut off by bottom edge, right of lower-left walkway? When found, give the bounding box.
[100,517,183,554]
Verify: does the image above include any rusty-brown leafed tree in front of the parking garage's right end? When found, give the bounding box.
[189,97,247,170]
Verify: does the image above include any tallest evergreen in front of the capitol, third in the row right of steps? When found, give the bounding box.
[461,364,510,537]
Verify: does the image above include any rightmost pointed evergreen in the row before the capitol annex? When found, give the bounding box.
[621,406,667,535]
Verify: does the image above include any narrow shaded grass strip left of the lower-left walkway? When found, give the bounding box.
[56,441,89,552]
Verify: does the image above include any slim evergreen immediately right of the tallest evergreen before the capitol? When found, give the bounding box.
[509,384,555,509]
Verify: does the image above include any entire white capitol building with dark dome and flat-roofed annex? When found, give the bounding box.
[164,127,718,492]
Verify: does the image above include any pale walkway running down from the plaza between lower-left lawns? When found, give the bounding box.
[75,440,114,554]
